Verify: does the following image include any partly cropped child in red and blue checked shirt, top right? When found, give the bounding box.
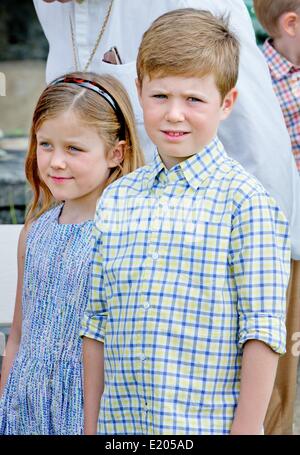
[254,0,300,172]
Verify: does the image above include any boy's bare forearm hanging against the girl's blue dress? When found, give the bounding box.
[83,337,104,435]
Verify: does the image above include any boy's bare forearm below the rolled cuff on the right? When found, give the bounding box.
[231,340,279,435]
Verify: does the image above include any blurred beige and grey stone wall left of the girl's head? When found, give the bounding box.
[0,60,45,224]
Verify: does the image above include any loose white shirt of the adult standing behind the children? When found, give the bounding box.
[33,0,300,259]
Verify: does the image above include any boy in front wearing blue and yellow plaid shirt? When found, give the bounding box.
[81,9,290,434]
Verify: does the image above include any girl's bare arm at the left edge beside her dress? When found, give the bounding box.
[0,226,28,396]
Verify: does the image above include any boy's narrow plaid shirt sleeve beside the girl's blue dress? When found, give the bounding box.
[80,214,107,342]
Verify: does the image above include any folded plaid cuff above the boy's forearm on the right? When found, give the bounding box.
[238,313,286,354]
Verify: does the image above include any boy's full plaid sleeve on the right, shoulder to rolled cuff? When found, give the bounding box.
[231,193,290,354]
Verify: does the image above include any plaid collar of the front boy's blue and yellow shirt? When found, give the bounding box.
[147,137,227,190]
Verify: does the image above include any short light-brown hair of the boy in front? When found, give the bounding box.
[137,8,239,100]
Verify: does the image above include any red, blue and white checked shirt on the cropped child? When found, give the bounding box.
[262,39,300,172]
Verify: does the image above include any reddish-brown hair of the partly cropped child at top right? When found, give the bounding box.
[253,0,300,38]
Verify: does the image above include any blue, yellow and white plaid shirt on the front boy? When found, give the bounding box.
[81,139,290,434]
